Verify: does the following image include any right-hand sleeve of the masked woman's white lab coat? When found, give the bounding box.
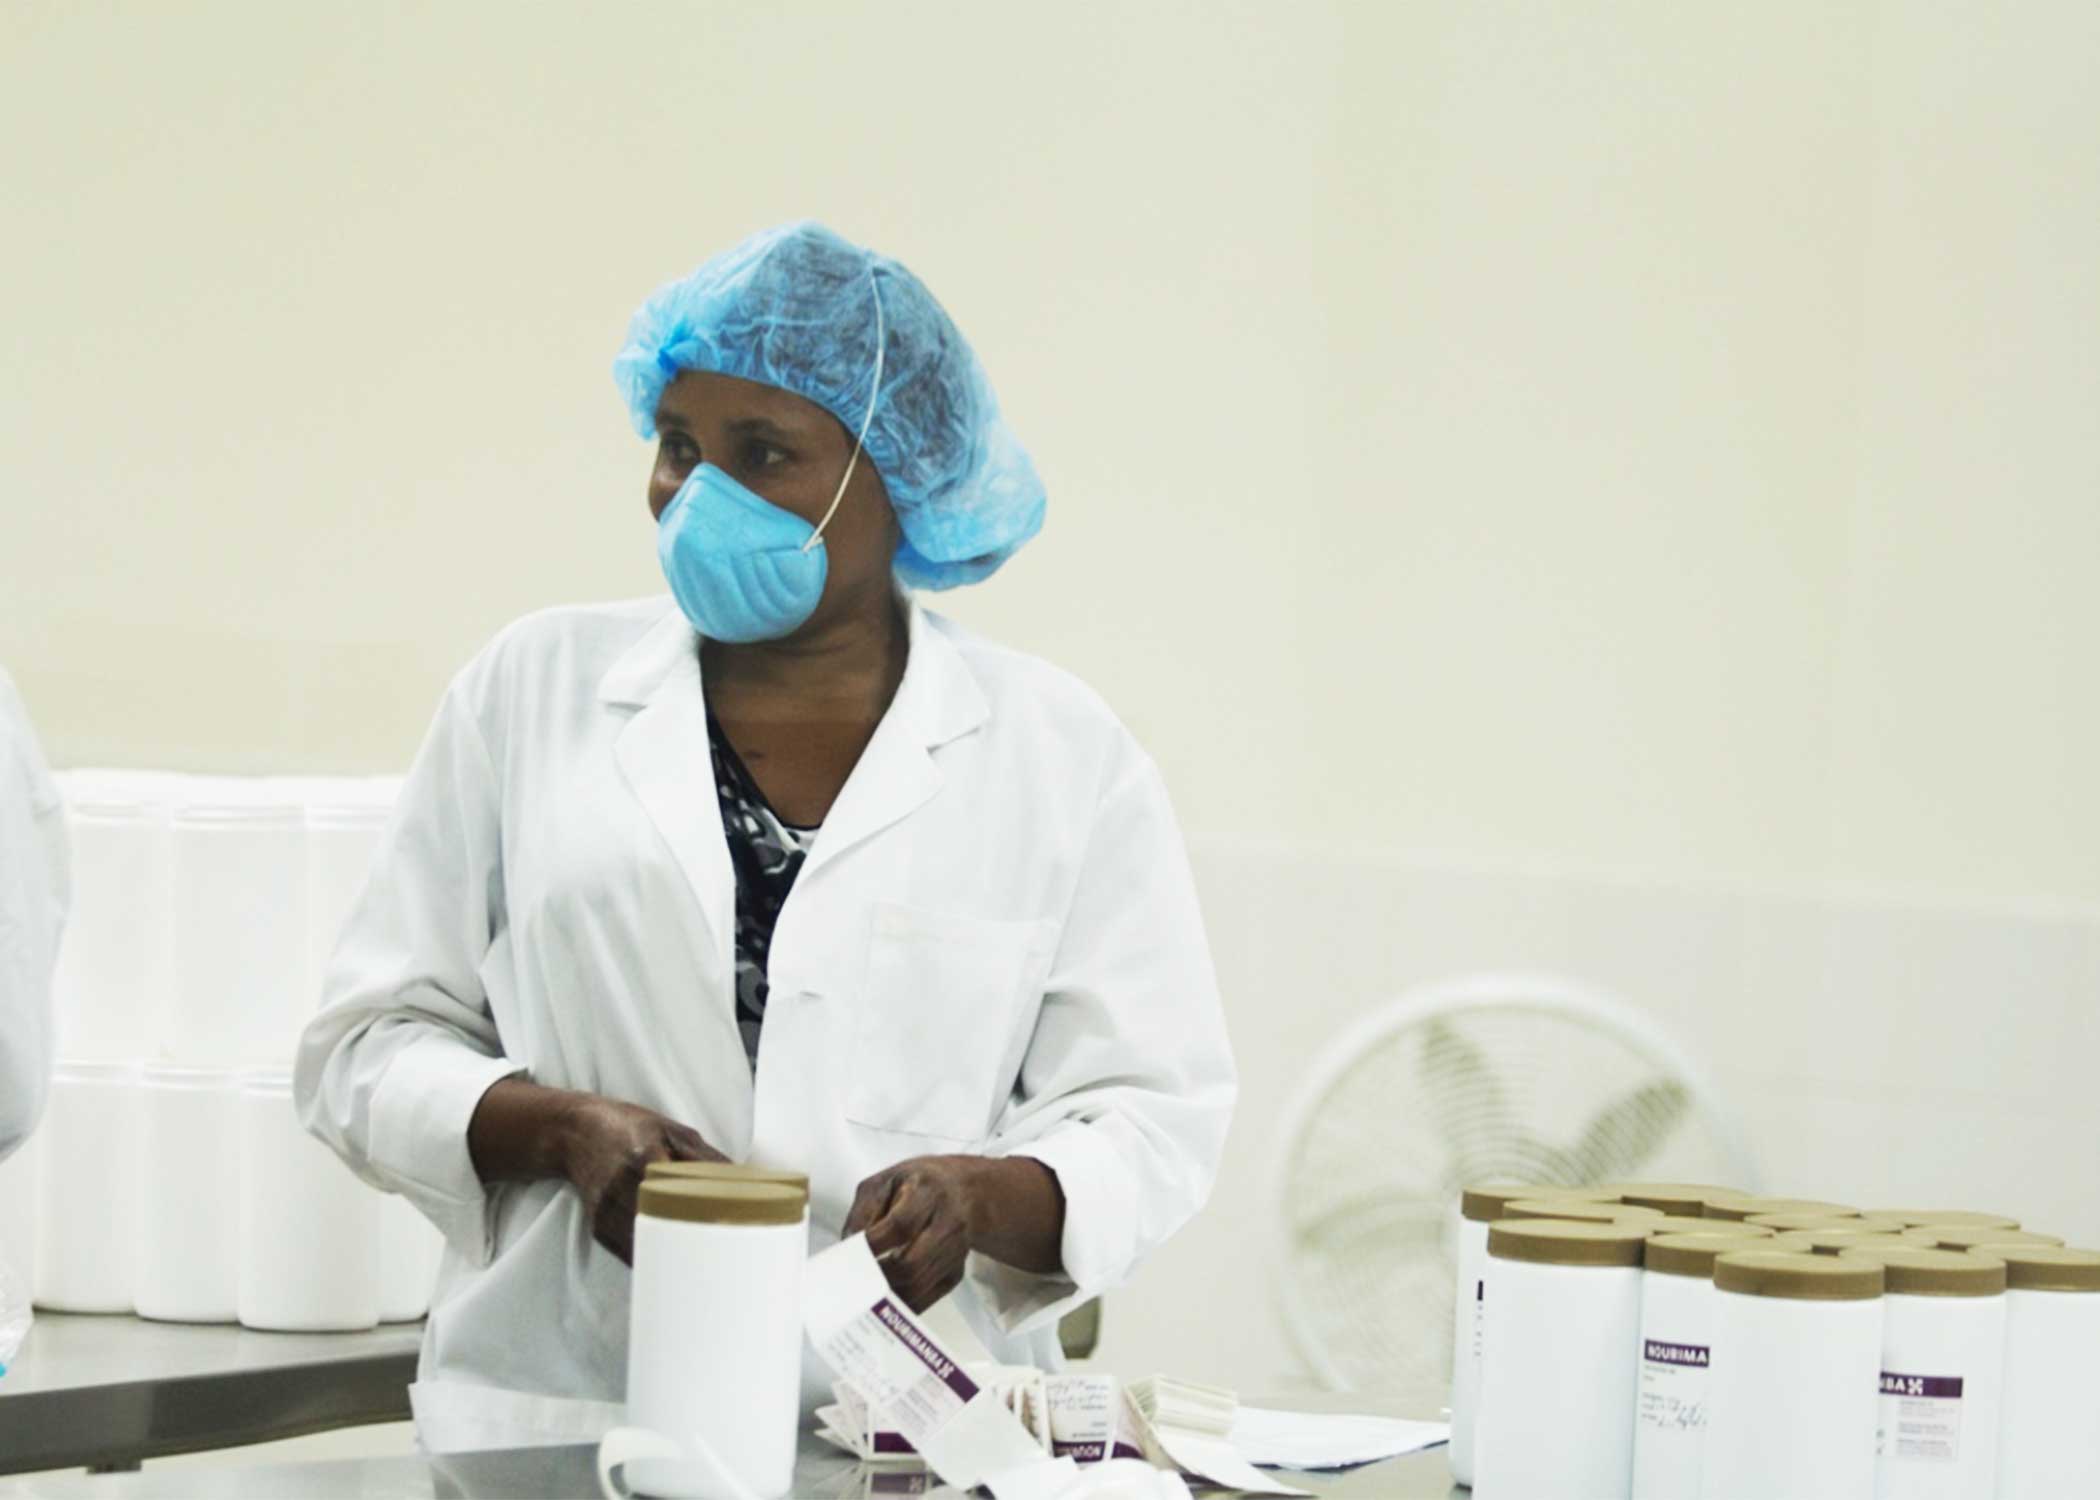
[968,744,1237,1334]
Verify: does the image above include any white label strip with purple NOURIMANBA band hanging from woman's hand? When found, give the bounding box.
[802,1235,1054,1494]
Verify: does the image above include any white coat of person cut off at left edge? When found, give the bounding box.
[0,670,71,1162]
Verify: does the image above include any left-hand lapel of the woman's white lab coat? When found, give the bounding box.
[599,609,735,954]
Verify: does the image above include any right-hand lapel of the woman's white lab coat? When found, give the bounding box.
[800,605,989,880]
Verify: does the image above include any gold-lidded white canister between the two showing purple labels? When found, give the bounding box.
[1699,1250,1882,1500]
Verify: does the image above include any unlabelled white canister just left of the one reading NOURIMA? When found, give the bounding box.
[1472,1218,1644,1500]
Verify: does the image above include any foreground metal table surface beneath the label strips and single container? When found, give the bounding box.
[0,1397,1466,1500]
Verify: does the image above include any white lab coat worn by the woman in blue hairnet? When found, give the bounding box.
[294,599,1235,1452]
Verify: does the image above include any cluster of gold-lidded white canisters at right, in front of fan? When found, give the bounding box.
[1451,1183,2100,1500]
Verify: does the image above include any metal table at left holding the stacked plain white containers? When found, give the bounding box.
[0,1313,422,1473]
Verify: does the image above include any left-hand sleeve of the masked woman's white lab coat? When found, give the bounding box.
[292,683,525,1267]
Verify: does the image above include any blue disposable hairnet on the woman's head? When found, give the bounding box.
[613,221,1044,588]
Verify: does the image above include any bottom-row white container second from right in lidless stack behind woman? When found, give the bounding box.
[235,1074,380,1332]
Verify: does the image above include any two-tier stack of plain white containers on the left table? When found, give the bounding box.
[0,771,441,1330]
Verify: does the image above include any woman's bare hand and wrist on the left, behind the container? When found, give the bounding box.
[466,1078,727,1265]
